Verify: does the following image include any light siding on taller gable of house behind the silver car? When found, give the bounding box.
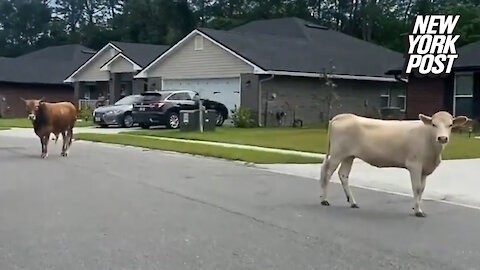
[74,48,117,82]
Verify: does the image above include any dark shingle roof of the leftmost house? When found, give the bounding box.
[0,44,91,84]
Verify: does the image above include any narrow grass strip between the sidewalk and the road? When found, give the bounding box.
[75,133,322,164]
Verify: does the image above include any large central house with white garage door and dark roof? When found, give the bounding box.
[135,18,405,125]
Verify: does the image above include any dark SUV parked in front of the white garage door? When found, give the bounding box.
[132,90,228,129]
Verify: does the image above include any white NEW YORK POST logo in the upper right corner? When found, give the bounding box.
[402,15,460,78]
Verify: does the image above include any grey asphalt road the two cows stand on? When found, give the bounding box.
[0,135,480,270]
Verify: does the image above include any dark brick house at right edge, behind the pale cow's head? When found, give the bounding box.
[387,42,480,119]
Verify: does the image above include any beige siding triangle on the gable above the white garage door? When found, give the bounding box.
[147,33,253,79]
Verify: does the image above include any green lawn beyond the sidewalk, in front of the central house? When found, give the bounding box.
[127,128,480,159]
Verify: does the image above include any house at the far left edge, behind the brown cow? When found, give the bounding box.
[0,45,94,117]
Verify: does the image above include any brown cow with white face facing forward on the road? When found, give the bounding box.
[22,98,77,158]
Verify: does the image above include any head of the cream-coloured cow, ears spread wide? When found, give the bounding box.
[418,112,468,144]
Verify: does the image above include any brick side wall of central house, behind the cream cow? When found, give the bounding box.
[258,76,405,126]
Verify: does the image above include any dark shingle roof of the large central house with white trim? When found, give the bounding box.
[139,18,403,80]
